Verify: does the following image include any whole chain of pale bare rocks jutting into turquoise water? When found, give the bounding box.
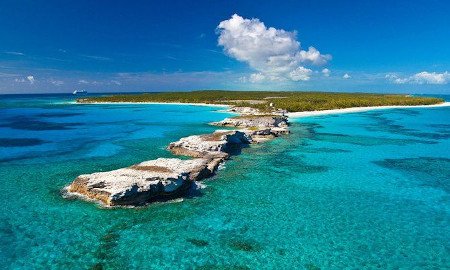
[66,107,289,207]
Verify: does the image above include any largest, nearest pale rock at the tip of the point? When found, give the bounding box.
[67,158,221,206]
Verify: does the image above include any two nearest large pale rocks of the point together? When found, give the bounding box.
[67,130,250,206]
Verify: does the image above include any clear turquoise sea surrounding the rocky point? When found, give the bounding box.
[0,96,450,269]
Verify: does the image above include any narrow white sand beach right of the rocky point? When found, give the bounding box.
[286,102,450,118]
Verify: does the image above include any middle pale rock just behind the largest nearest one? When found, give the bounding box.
[167,130,251,159]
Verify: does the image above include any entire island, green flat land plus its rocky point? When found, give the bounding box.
[64,91,444,207]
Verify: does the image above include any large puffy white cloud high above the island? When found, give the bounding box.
[217,14,331,82]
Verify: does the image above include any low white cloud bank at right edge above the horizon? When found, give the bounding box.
[386,71,450,84]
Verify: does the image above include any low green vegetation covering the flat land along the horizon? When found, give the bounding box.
[78,90,444,112]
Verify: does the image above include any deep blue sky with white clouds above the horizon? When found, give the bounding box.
[0,0,450,94]
